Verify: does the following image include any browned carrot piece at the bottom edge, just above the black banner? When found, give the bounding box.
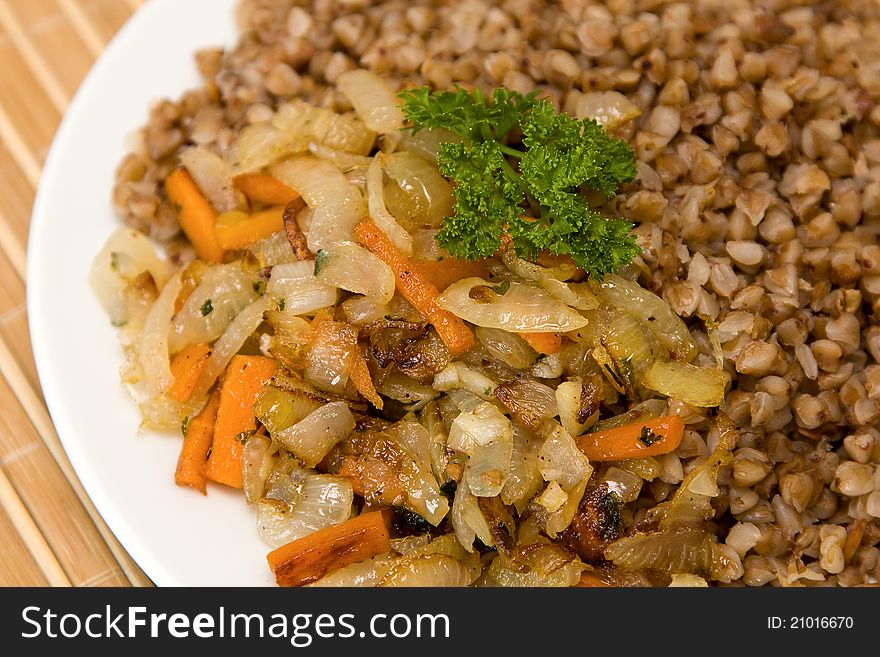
[266,511,391,586]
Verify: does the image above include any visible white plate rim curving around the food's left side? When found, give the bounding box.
[27,0,271,586]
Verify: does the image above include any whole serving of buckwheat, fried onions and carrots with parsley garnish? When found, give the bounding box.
[91,0,880,586]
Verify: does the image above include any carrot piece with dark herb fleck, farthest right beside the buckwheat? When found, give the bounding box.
[575,415,684,461]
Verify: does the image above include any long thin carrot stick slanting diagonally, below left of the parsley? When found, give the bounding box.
[354,219,474,357]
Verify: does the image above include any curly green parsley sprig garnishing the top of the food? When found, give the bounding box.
[399,87,640,276]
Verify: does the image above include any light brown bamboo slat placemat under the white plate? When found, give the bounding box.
[0,0,151,586]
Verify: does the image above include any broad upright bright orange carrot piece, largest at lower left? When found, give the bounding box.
[205,355,278,488]
